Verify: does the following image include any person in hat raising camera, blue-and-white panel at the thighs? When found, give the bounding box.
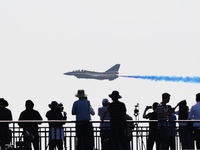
[46,101,67,150]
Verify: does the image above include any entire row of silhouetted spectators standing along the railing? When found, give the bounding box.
[0,90,200,150]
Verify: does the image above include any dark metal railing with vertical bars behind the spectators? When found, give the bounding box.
[0,120,197,150]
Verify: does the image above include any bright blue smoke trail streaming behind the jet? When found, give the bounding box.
[121,75,200,83]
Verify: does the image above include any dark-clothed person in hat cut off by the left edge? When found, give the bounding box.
[0,98,12,149]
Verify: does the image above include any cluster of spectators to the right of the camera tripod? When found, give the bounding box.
[143,93,200,150]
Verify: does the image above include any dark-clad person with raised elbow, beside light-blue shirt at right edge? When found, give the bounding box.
[177,100,194,149]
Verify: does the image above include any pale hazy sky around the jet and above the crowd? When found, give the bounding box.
[0,0,200,120]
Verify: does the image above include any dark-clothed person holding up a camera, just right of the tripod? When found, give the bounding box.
[143,102,160,150]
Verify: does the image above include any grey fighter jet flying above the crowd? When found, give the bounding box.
[64,64,120,81]
